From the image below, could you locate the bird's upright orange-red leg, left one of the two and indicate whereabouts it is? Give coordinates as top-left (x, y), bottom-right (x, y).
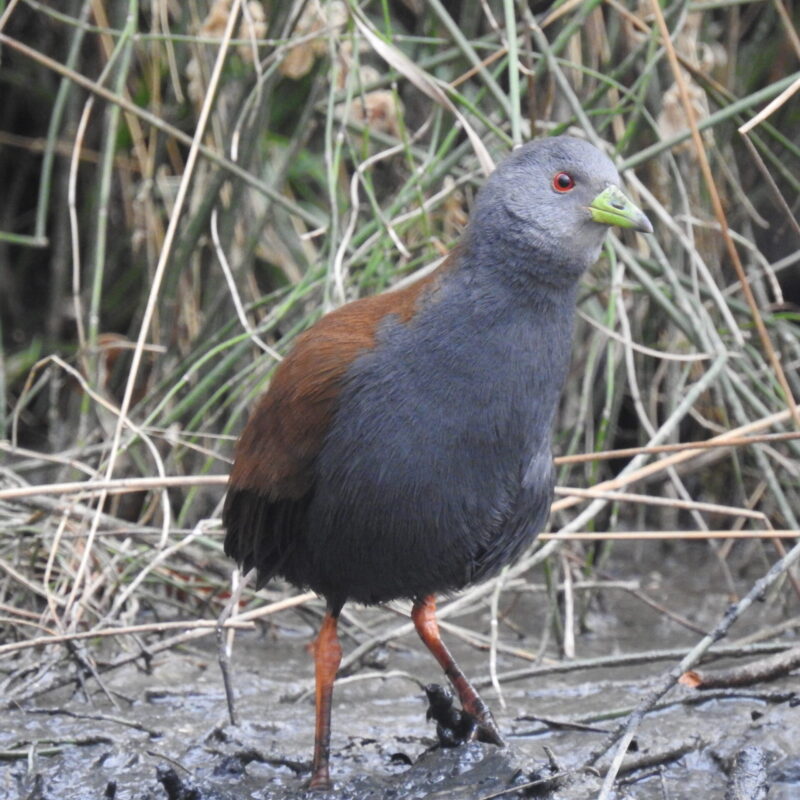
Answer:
top-left (309, 611), bottom-right (342, 789)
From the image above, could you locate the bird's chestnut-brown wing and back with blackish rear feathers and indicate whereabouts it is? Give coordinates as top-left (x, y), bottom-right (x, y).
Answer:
top-left (223, 255), bottom-right (453, 585)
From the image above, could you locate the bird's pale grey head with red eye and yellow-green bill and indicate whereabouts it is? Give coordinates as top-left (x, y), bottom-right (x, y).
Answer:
top-left (471, 136), bottom-right (653, 283)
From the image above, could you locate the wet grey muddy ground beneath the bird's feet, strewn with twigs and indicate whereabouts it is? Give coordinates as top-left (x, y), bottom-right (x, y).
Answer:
top-left (0, 543), bottom-right (800, 800)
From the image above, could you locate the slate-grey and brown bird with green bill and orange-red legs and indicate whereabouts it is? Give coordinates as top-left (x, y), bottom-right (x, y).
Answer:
top-left (223, 136), bottom-right (653, 789)
